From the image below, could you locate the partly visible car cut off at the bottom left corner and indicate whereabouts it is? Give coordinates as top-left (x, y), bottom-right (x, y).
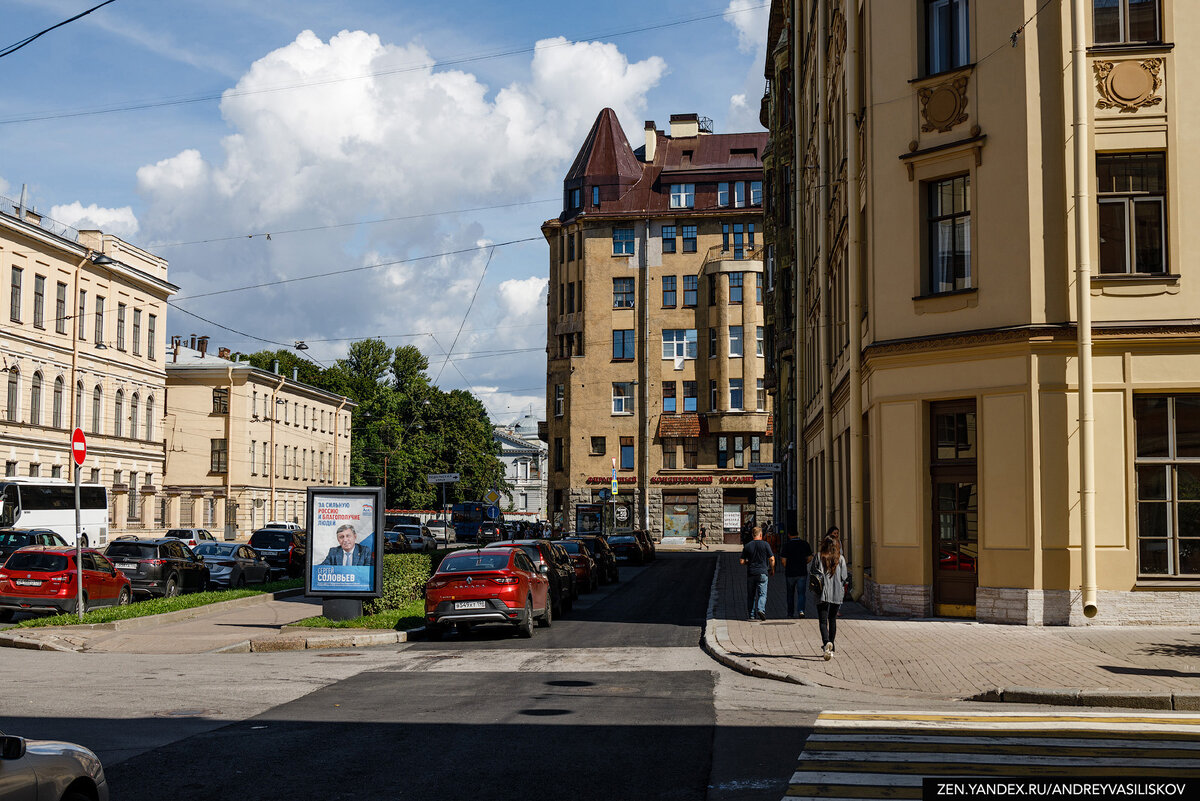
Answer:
top-left (0, 733), bottom-right (108, 801)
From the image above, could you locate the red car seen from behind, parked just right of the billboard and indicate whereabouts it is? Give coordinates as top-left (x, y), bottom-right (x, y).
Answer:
top-left (425, 548), bottom-right (552, 637)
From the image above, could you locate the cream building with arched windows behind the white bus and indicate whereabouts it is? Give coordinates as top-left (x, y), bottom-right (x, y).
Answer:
top-left (0, 198), bottom-right (179, 544)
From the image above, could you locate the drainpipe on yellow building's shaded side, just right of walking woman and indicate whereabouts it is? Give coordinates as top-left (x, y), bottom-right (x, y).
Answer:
top-left (842, 0), bottom-right (864, 601)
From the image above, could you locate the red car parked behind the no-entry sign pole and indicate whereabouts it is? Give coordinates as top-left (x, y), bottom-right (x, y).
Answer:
top-left (0, 546), bottom-right (133, 621)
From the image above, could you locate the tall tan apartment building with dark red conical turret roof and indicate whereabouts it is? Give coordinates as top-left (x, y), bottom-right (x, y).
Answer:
top-left (542, 109), bottom-right (774, 542)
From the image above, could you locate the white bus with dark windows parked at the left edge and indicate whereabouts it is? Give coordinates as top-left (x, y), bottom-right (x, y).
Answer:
top-left (0, 478), bottom-right (108, 546)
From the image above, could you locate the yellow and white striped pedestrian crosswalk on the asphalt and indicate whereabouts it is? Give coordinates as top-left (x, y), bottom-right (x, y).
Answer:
top-left (786, 711), bottom-right (1200, 799)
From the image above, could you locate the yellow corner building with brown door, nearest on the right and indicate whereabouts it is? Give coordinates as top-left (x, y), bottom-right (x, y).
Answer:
top-left (763, 0), bottom-right (1200, 625)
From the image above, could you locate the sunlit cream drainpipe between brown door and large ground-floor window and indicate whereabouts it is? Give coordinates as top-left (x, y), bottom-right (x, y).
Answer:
top-left (1070, 0), bottom-right (1099, 618)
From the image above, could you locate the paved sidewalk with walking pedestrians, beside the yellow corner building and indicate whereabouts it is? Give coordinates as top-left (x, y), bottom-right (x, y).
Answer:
top-left (702, 546), bottom-right (1200, 710)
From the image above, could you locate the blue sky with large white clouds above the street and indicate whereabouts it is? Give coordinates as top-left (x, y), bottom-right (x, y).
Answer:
top-left (0, 0), bottom-right (770, 423)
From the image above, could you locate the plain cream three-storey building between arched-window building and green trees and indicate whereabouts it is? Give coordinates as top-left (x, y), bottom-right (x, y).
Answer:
top-left (160, 335), bottom-right (356, 540)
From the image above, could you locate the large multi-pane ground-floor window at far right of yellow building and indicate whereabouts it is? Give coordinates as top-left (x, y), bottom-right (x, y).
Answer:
top-left (1133, 395), bottom-right (1200, 576)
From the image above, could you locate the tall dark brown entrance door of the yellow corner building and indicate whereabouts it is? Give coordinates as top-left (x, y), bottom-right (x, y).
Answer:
top-left (930, 401), bottom-right (979, 618)
